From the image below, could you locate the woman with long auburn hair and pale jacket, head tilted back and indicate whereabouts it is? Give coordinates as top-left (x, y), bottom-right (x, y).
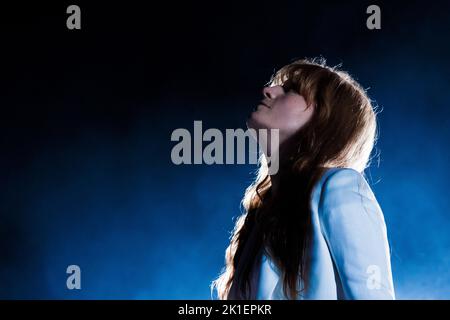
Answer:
top-left (211, 60), bottom-right (395, 299)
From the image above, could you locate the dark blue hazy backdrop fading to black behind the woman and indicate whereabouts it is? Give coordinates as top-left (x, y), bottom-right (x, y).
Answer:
top-left (0, 1), bottom-right (450, 299)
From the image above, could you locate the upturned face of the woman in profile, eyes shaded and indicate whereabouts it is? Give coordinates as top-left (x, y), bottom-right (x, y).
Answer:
top-left (247, 85), bottom-right (314, 139)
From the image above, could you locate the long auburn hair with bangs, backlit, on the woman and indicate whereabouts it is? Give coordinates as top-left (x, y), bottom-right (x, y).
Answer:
top-left (211, 58), bottom-right (377, 299)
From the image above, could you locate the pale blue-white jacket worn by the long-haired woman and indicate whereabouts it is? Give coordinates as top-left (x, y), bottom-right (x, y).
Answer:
top-left (230, 168), bottom-right (395, 300)
